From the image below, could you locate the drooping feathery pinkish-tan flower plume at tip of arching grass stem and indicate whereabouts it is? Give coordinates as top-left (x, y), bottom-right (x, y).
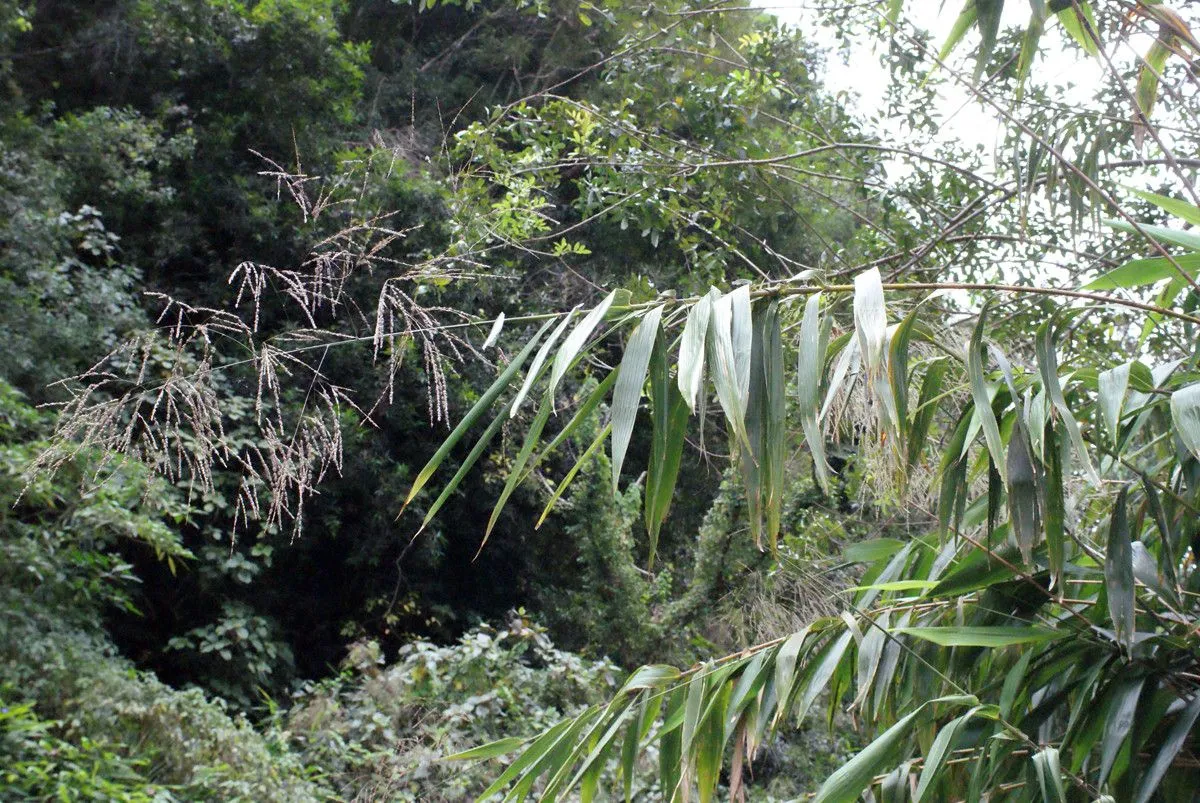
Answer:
top-left (29, 150), bottom-right (474, 535)
